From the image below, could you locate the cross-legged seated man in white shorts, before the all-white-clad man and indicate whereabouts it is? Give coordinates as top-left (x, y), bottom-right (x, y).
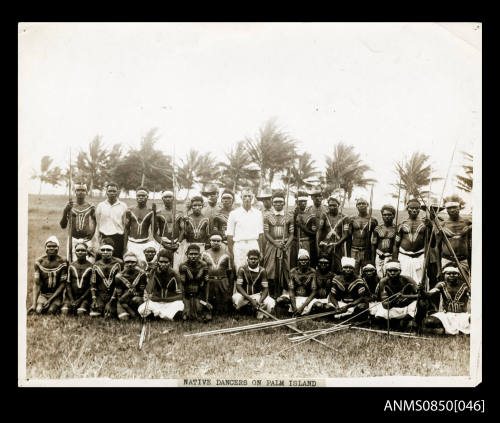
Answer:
top-left (233, 250), bottom-right (275, 319)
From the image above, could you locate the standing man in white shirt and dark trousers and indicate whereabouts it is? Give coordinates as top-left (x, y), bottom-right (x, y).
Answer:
top-left (95, 182), bottom-right (127, 259)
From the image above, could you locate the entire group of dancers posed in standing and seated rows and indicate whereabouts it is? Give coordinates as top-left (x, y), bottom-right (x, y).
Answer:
top-left (30, 182), bottom-right (472, 334)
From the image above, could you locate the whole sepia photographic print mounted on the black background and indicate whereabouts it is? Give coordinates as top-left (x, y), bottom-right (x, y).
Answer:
top-left (17, 22), bottom-right (483, 388)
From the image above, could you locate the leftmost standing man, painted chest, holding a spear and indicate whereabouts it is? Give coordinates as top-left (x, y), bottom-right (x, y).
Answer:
top-left (59, 183), bottom-right (96, 263)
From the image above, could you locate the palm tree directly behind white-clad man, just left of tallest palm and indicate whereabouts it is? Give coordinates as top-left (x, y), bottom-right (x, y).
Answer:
top-left (219, 141), bottom-right (259, 192)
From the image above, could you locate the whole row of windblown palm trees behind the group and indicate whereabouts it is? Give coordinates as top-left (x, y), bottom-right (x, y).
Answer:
top-left (32, 120), bottom-right (472, 204)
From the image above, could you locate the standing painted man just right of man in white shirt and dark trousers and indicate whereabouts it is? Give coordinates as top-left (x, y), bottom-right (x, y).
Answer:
top-left (124, 187), bottom-right (156, 260)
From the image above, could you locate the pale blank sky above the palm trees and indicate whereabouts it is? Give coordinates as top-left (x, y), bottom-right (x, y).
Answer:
top-left (18, 23), bottom-right (482, 207)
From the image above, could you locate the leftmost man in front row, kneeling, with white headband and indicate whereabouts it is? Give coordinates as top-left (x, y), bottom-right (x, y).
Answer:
top-left (28, 236), bottom-right (68, 314)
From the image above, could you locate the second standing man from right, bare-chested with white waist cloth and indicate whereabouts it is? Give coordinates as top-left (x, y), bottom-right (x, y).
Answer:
top-left (392, 199), bottom-right (432, 284)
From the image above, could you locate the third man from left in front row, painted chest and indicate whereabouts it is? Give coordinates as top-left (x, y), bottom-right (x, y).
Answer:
top-left (90, 242), bottom-right (123, 317)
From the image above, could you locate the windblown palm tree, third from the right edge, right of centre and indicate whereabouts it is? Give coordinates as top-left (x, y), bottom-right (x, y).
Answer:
top-left (324, 142), bottom-right (376, 207)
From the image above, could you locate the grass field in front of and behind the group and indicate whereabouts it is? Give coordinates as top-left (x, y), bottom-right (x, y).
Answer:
top-left (22, 196), bottom-right (470, 379)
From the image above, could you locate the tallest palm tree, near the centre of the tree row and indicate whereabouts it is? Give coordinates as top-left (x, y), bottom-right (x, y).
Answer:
top-left (244, 119), bottom-right (296, 187)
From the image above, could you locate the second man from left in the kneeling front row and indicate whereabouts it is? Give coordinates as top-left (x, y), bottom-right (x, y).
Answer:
top-left (61, 242), bottom-right (92, 316)
